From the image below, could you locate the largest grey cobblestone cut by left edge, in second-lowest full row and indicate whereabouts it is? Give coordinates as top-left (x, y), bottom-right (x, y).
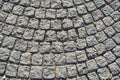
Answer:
top-left (0, 48), bottom-right (10, 61)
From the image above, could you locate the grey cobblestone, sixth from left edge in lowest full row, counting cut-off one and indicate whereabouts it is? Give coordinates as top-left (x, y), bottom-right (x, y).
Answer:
top-left (56, 66), bottom-right (67, 79)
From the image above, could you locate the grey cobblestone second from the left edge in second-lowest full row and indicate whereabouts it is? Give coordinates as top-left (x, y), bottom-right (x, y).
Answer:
top-left (9, 50), bottom-right (21, 64)
